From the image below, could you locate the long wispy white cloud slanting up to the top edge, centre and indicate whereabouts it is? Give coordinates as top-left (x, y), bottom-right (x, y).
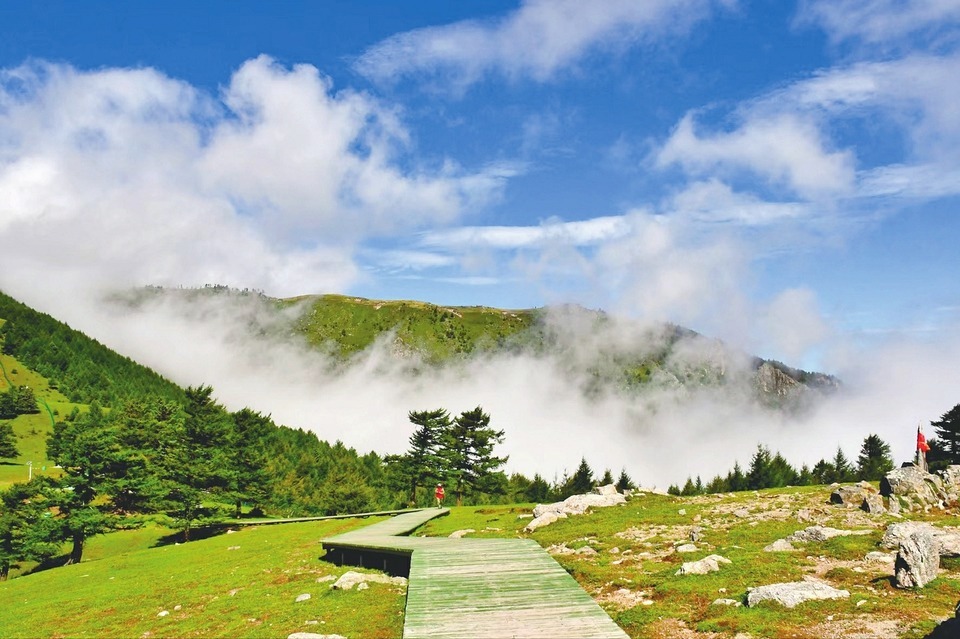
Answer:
top-left (356, 0), bottom-right (731, 86)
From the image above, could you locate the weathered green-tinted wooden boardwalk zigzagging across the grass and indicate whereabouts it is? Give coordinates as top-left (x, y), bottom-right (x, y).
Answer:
top-left (323, 509), bottom-right (627, 639)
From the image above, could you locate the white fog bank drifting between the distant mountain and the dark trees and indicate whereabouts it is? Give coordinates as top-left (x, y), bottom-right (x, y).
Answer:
top-left (3, 282), bottom-right (960, 488)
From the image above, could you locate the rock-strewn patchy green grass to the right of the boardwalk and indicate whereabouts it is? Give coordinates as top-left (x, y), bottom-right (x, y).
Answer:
top-left (417, 486), bottom-right (960, 639)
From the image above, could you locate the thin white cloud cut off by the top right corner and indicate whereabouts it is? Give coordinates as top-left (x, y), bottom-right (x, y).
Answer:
top-left (798, 0), bottom-right (960, 46)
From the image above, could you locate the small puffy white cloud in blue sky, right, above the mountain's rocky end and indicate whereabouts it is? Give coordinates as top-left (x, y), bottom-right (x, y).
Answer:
top-left (656, 113), bottom-right (854, 198)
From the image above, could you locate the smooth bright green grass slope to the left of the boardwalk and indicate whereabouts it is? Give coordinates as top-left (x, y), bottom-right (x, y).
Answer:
top-left (0, 519), bottom-right (404, 639)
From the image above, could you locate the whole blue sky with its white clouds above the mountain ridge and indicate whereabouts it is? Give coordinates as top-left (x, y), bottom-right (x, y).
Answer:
top-left (0, 0), bottom-right (960, 370)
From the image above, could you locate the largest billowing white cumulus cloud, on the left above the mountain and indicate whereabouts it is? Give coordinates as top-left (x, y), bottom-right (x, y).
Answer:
top-left (0, 56), bottom-right (516, 308)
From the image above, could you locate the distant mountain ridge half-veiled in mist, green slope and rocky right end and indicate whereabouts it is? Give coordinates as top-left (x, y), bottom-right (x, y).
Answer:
top-left (107, 285), bottom-right (840, 406)
